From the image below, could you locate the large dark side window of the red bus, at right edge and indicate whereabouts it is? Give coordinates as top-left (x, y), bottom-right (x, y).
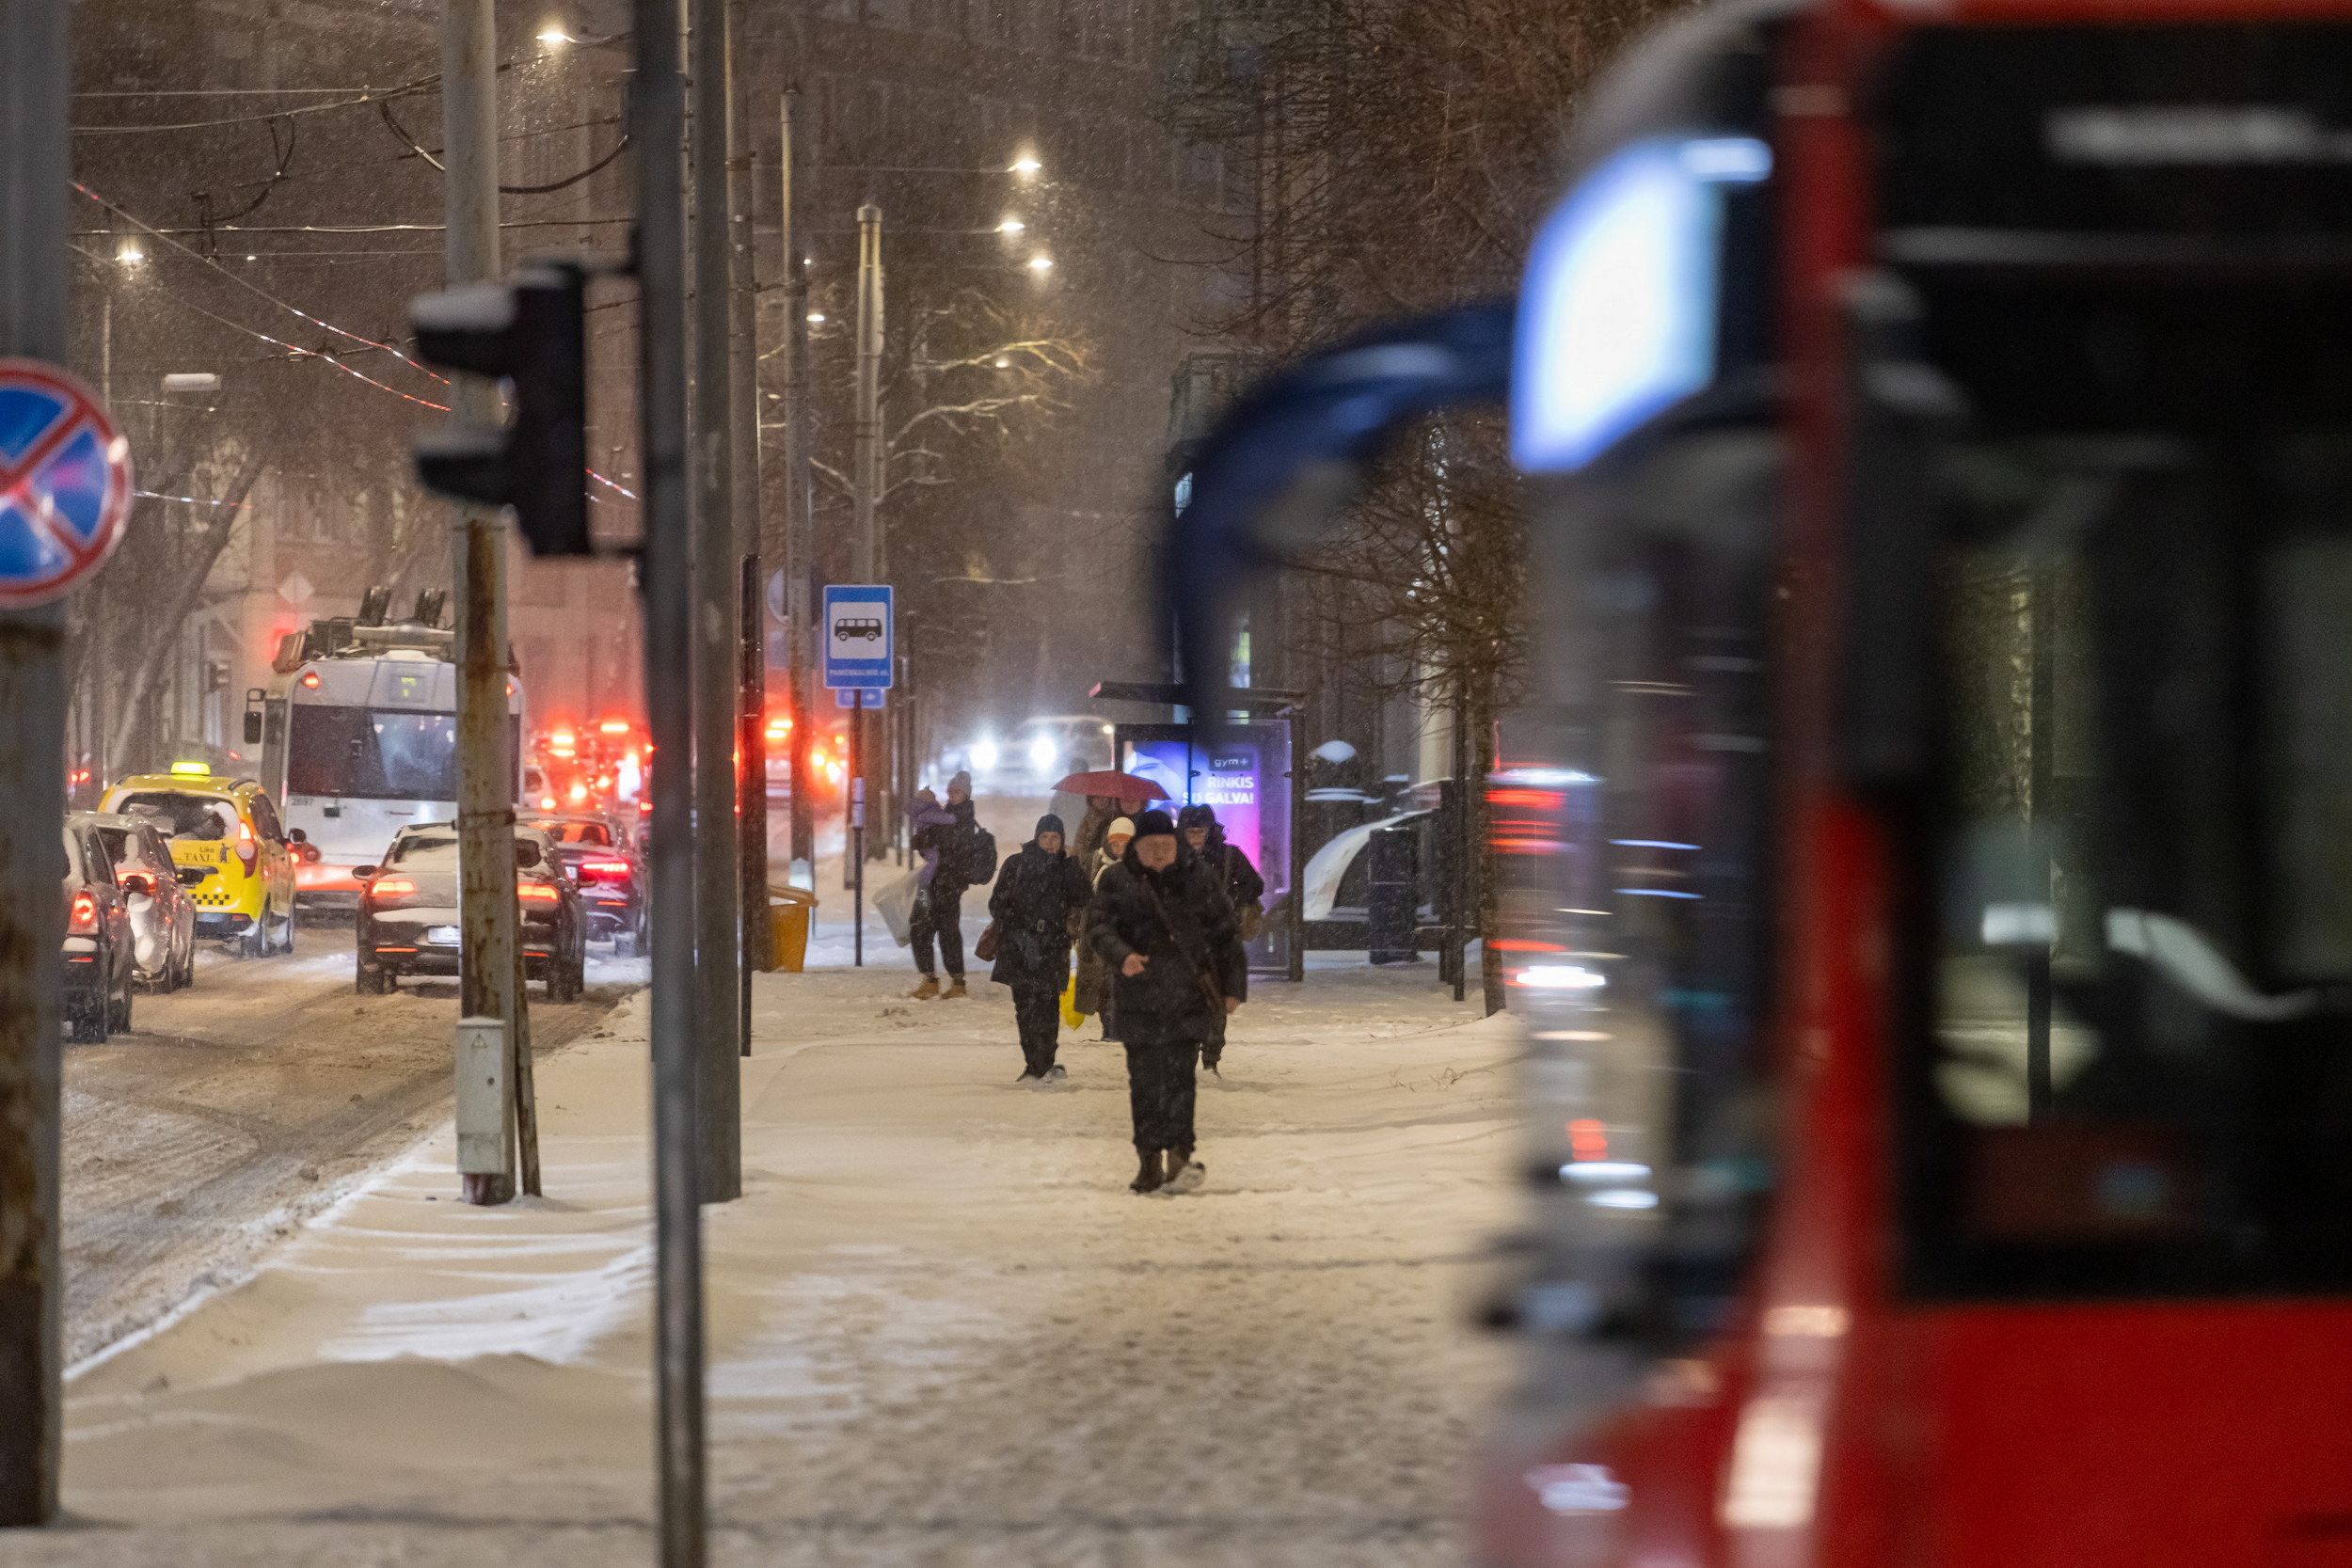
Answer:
top-left (1910, 428), bottom-right (2352, 1295)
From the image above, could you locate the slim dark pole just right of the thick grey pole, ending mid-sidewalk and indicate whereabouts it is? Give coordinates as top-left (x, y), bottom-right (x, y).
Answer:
top-left (727, 0), bottom-right (776, 1029)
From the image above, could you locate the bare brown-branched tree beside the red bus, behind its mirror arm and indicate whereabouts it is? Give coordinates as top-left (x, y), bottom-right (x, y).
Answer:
top-left (1174, 0), bottom-right (1673, 1011)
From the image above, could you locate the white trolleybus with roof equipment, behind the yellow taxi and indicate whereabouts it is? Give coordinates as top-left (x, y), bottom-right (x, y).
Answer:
top-left (245, 588), bottom-right (522, 910)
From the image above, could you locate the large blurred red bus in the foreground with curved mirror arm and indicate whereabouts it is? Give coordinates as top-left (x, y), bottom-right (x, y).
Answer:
top-left (1174, 0), bottom-right (2352, 1568)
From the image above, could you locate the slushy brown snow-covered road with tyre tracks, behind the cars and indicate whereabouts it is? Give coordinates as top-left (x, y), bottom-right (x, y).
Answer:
top-left (64, 924), bottom-right (643, 1364)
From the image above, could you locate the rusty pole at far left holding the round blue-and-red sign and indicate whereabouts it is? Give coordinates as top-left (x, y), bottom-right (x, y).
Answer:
top-left (0, 0), bottom-right (73, 1526)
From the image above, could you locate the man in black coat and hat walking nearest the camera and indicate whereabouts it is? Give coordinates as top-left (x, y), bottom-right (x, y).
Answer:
top-left (1087, 811), bottom-right (1249, 1192)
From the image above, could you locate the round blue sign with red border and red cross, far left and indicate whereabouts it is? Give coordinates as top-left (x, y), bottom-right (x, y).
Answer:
top-left (0, 359), bottom-right (132, 609)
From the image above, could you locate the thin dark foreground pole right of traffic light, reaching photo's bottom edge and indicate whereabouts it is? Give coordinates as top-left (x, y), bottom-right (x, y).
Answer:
top-left (633, 0), bottom-right (708, 1542)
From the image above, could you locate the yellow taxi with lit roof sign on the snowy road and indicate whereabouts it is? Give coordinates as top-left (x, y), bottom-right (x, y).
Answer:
top-left (99, 762), bottom-right (301, 959)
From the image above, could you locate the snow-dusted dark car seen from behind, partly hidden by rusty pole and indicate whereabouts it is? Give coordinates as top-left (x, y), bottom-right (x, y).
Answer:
top-left (351, 823), bottom-right (588, 1002)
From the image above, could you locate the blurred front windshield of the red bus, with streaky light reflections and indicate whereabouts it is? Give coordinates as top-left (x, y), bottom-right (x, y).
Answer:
top-left (1489, 430), bottom-right (1778, 1350)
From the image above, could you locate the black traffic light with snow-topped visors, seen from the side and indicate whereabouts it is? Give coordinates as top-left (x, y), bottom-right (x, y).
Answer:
top-left (409, 261), bottom-right (596, 555)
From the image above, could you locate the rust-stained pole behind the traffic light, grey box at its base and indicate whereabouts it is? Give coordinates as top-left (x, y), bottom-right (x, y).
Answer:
top-left (442, 0), bottom-right (539, 1204)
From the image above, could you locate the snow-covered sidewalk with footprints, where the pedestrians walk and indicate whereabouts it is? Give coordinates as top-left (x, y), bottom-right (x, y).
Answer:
top-left (13, 949), bottom-right (1515, 1568)
